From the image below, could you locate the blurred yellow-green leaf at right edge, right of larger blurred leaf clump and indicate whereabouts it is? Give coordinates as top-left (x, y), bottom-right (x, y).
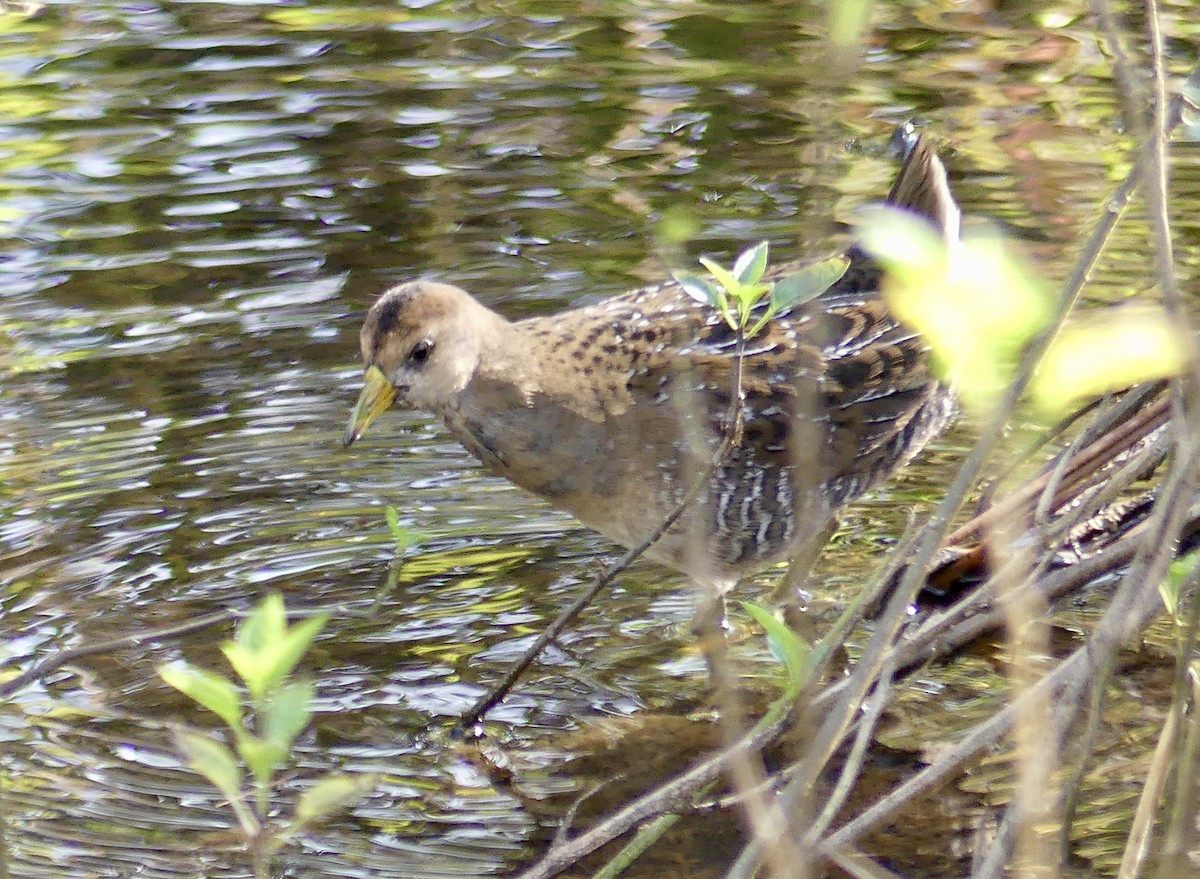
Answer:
top-left (1030, 309), bottom-right (1189, 418)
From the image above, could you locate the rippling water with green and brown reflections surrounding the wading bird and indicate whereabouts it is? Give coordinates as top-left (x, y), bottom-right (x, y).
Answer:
top-left (0, 0), bottom-right (1200, 877)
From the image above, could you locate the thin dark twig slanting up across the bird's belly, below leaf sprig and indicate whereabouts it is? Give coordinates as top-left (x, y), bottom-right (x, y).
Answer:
top-left (458, 338), bottom-right (745, 730)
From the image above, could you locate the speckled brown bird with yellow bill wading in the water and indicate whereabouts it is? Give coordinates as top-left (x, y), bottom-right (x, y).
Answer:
top-left (346, 130), bottom-right (959, 587)
